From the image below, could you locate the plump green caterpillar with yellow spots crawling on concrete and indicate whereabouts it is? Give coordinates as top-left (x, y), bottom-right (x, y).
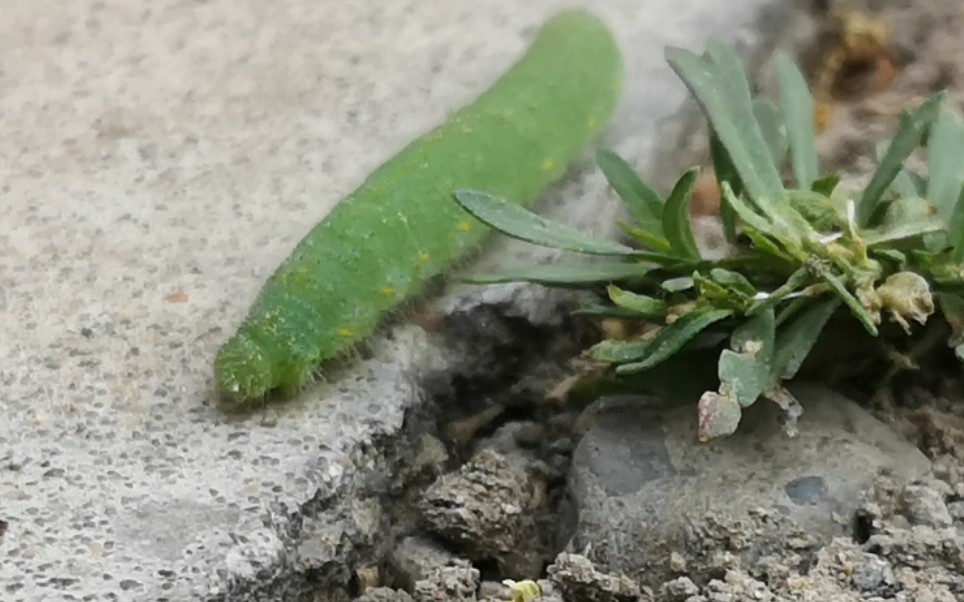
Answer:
top-left (214, 11), bottom-right (622, 405)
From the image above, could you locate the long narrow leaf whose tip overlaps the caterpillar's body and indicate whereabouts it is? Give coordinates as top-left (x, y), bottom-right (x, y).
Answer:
top-left (455, 190), bottom-right (652, 258)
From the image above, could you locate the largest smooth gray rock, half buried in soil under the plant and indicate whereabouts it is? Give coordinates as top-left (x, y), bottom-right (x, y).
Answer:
top-left (567, 386), bottom-right (929, 585)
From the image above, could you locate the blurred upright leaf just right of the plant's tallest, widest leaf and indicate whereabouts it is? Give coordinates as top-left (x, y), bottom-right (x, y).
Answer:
top-left (774, 53), bottom-right (816, 194)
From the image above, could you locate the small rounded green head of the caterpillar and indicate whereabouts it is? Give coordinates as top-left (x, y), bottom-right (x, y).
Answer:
top-left (214, 333), bottom-right (274, 406)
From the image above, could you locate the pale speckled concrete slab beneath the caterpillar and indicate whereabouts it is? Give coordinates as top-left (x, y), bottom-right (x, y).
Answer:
top-left (0, 0), bottom-right (792, 602)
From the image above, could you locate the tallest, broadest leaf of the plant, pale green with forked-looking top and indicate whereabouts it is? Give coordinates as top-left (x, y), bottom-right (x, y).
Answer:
top-left (665, 42), bottom-right (783, 203)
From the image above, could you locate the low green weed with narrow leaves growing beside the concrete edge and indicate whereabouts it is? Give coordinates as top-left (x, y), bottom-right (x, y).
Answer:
top-left (455, 42), bottom-right (964, 441)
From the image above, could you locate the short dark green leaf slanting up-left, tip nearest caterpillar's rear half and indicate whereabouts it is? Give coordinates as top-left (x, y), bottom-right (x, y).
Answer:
top-left (596, 149), bottom-right (670, 251)
